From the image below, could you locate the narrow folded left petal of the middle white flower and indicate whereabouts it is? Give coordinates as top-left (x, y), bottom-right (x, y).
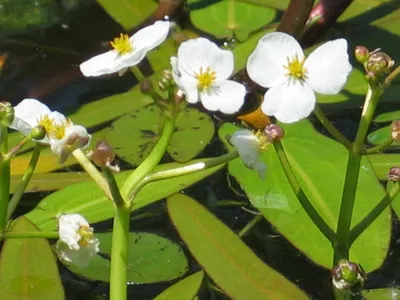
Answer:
top-left (170, 57), bottom-right (199, 103)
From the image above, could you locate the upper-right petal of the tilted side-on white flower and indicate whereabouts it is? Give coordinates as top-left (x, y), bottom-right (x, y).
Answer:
top-left (129, 21), bottom-right (171, 51)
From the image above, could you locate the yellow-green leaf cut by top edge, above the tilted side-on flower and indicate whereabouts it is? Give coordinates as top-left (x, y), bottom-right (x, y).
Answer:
top-left (97, 0), bottom-right (158, 30)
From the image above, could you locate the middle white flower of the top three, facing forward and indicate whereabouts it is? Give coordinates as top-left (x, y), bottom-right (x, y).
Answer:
top-left (171, 38), bottom-right (246, 114)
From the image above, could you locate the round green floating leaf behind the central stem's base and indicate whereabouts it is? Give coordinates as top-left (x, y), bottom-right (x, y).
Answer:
top-left (66, 232), bottom-right (188, 284)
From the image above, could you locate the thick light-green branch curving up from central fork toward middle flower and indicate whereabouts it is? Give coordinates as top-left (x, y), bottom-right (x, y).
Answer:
top-left (121, 114), bottom-right (175, 199)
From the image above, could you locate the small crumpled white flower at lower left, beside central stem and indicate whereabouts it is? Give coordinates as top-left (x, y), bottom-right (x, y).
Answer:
top-left (57, 214), bottom-right (100, 267)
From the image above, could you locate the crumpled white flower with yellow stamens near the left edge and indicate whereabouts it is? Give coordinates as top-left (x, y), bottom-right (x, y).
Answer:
top-left (10, 99), bottom-right (91, 162)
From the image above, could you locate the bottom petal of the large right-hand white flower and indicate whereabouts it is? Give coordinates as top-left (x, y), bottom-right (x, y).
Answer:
top-left (261, 81), bottom-right (315, 123)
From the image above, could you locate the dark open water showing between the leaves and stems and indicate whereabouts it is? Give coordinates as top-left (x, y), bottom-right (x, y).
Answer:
top-left (0, 4), bottom-right (400, 300)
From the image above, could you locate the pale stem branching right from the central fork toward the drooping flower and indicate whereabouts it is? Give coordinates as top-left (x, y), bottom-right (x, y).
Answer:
top-left (131, 150), bottom-right (239, 197)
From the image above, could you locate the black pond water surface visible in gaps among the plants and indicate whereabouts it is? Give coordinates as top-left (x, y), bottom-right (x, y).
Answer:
top-left (0, 1), bottom-right (400, 300)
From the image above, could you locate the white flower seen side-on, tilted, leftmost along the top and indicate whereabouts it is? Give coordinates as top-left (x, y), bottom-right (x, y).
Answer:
top-left (80, 21), bottom-right (170, 77)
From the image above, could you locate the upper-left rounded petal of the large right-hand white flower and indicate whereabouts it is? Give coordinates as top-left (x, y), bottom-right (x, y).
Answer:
top-left (247, 32), bottom-right (304, 88)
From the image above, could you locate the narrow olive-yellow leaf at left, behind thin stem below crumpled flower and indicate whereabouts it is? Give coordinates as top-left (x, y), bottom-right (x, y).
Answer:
top-left (11, 172), bottom-right (90, 193)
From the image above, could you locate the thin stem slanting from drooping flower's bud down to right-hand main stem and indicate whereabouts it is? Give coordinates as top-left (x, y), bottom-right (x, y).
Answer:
top-left (274, 141), bottom-right (336, 243)
